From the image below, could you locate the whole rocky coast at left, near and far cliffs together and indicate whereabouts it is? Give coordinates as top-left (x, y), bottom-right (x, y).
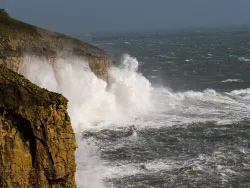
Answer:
top-left (0, 9), bottom-right (112, 188)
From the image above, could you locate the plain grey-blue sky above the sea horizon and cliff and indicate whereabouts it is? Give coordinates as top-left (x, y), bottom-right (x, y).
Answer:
top-left (0, 0), bottom-right (250, 33)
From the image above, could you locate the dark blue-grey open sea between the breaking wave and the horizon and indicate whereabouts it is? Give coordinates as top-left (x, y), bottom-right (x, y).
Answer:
top-left (92, 27), bottom-right (250, 90)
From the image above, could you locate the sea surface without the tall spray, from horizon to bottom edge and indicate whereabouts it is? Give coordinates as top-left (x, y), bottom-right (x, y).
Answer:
top-left (76, 27), bottom-right (250, 188)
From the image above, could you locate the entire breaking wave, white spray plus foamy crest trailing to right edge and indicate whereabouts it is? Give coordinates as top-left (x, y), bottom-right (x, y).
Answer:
top-left (18, 55), bottom-right (250, 188)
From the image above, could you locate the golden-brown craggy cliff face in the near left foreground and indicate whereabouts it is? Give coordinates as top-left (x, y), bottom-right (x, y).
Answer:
top-left (0, 65), bottom-right (76, 188)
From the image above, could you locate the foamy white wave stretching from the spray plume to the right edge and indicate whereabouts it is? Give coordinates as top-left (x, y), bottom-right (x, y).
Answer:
top-left (146, 88), bottom-right (250, 126)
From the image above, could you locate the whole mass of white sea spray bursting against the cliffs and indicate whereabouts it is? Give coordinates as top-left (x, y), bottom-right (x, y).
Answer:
top-left (18, 55), bottom-right (153, 188)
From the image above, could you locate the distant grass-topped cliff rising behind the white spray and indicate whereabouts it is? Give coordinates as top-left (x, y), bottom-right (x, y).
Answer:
top-left (0, 9), bottom-right (112, 80)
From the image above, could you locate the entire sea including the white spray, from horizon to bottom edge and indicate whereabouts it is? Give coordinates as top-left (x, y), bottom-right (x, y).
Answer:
top-left (19, 27), bottom-right (250, 188)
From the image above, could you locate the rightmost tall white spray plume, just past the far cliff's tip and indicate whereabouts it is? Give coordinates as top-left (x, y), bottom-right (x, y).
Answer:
top-left (108, 55), bottom-right (153, 120)
